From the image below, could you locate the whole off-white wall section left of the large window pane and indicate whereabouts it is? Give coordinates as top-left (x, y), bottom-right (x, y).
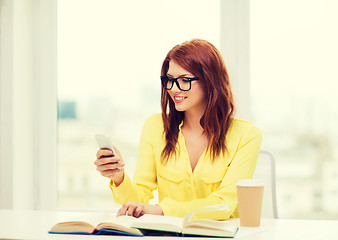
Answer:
top-left (0, 0), bottom-right (56, 209)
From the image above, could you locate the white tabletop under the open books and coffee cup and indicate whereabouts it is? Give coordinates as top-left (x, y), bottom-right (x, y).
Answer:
top-left (0, 210), bottom-right (338, 240)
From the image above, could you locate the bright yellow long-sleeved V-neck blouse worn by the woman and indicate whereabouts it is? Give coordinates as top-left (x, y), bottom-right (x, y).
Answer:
top-left (110, 114), bottom-right (262, 219)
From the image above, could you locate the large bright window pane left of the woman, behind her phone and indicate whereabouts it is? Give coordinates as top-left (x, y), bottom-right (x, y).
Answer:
top-left (58, 0), bottom-right (220, 208)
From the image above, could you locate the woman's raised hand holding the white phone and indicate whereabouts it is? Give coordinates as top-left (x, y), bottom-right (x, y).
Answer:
top-left (94, 147), bottom-right (124, 186)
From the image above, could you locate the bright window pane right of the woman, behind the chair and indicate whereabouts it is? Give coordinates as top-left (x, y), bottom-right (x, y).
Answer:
top-left (251, 0), bottom-right (338, 219)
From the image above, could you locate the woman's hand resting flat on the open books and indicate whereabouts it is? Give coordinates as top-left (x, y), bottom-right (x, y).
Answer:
top-left (117, 201), bottom-right (163, 218)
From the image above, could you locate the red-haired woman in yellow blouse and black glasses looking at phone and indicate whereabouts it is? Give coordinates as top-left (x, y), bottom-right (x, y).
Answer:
top-left (95, 39), bottom-right (261, 219)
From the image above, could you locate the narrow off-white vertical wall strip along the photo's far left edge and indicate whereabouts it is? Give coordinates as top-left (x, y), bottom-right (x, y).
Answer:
top-left (0, 1), bottom-right (13, 208)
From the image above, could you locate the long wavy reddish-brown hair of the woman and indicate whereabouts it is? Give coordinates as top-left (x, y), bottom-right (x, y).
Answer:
top-left (161, 39), bottom-right (235, 164)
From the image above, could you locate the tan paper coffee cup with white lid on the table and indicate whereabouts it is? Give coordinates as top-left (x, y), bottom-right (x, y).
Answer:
top-left (237, 179), bottom-right (264, 227)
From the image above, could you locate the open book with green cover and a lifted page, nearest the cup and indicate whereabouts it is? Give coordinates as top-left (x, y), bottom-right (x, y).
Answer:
top-left (132, 204), bottom-right (239, 237)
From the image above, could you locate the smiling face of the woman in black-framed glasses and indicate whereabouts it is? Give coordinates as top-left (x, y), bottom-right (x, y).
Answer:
top-left (167, 61), bottom-right (207, 114)
